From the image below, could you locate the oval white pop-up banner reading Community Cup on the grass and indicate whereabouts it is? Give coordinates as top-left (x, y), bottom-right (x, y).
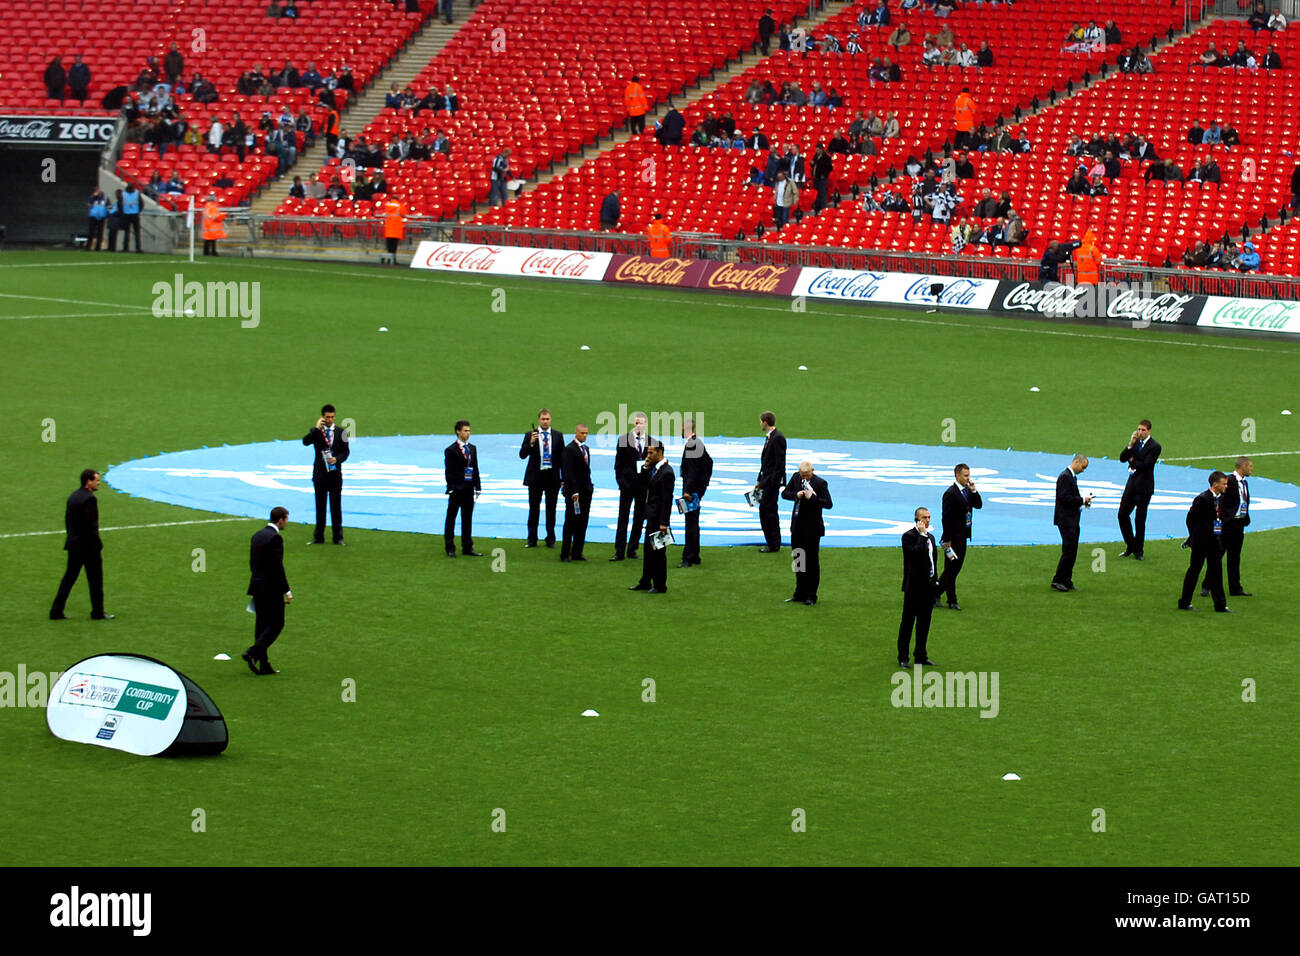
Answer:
top-left (46, 654), bottom-right (229, 757)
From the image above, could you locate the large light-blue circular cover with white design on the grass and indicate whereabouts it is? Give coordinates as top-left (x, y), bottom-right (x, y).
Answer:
top-left (105, 434), bottom-right (1300, 548)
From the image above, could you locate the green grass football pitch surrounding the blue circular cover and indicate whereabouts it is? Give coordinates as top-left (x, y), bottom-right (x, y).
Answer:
top-left (0, 252), bottom-right (1300, 866)
